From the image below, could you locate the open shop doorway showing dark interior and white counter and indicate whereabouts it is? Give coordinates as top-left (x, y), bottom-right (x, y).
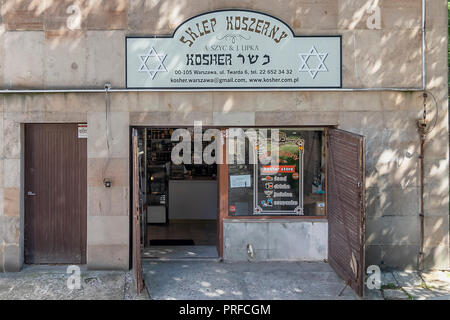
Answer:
top-left (134, 127), bottom-right (219, 259)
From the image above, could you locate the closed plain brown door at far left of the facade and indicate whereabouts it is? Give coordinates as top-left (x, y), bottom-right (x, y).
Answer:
top-left (24, 124), bottom-right (87, 264)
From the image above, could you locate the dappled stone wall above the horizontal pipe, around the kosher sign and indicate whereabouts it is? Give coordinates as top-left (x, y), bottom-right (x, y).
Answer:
top-left (0, 0), bottom-right (428, 88)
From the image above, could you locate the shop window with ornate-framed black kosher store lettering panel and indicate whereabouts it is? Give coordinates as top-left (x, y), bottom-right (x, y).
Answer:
top-left (227, 128), bottom-right (326, 216)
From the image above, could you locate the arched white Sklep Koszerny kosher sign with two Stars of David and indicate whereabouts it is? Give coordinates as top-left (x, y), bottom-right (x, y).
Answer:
top-left (126, 10), bottom-right (342, 90)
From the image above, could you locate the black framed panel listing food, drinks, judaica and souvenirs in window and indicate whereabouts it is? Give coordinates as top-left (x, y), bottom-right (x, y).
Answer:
top-left (254, 130), bottom-right (304, 215)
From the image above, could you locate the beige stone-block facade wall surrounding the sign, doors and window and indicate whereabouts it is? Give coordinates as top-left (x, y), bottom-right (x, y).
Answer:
top-left (0, 0), bottom-right (449, 271)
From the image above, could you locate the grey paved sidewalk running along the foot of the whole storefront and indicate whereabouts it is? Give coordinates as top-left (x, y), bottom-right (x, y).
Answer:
top-left (0, 260), bottom-right (450, 300)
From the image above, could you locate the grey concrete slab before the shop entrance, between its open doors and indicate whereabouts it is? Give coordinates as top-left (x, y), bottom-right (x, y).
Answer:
top-left (143, 260), bottom-right (357, 300)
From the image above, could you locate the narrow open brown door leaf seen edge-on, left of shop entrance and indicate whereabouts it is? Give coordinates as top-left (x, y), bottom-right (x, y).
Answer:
top-left (132, 129), bottom-right (144, 294)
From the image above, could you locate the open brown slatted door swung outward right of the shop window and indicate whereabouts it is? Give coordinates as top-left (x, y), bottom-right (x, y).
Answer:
top-left (327, 129), bottom-right (365, 296)
